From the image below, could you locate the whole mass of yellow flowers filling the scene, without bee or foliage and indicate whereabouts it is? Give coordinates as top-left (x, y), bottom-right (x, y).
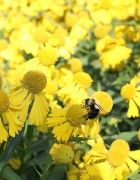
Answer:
top-left (0, 0), bottom-right (140, 180)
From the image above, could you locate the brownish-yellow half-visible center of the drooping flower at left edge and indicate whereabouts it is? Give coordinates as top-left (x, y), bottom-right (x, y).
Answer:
top-left (0, 90), bottom-right (9, 114)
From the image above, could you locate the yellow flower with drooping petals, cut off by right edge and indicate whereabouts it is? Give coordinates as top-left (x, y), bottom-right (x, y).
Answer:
top-left (121, 76), bottom-right (140, 117)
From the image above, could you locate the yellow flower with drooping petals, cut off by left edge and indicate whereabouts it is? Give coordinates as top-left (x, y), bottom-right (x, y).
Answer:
top-left (0, 90), bottom-right (22, 143)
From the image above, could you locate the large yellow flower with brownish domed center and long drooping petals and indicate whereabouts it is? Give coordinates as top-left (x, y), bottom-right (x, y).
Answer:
top-left (11, 61), bottom-right (48, 126)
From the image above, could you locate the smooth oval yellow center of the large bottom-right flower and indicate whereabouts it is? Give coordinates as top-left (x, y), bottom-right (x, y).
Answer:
top-left (107, 139), bottom-right (130, 166)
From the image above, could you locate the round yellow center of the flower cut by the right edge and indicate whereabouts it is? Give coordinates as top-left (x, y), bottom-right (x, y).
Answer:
top-left (121, 84), bottom-right (136, 100)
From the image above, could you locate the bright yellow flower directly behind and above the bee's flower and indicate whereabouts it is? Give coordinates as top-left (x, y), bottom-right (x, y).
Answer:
top-left (57, 68), bottom-right (93, 104)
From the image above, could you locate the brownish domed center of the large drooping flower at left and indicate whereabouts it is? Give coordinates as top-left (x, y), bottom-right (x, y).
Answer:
top-left (22, 71), bottom-right (47, 94)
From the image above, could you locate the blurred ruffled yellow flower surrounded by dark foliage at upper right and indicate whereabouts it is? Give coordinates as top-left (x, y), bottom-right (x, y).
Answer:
top-left (96, 36), bottom-right (132, 70)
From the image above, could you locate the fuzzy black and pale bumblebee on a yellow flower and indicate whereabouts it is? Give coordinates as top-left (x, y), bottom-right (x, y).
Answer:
top-left (83, 98), bottom-right (101, 120)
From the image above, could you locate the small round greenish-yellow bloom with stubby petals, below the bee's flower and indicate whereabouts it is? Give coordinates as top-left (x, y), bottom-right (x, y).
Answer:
top-left (50, 144), bottom-right (74, 164)
